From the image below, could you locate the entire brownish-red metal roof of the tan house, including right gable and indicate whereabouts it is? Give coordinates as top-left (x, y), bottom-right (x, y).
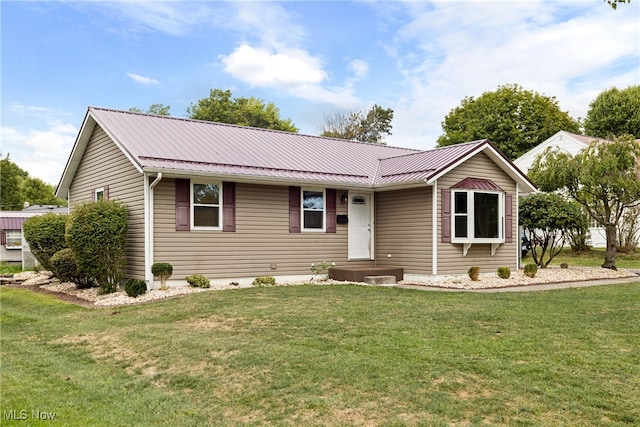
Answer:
top-left (58, 107), bottom-right (534, 197)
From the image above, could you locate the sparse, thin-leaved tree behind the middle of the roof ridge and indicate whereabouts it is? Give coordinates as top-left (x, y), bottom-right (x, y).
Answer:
top-left (320, 105), bottom-right (393, 144)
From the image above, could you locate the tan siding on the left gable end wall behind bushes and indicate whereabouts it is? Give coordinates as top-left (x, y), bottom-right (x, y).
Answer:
top-left (69, 125), bottom-right (144, 279)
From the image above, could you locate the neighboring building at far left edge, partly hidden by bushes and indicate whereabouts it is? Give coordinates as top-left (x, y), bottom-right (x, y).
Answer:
top-left (0, 205), bottom-right (67, 269)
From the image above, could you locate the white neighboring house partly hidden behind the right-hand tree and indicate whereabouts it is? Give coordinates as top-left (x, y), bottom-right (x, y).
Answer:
top-left (513, 130), bottom-right (607, 248)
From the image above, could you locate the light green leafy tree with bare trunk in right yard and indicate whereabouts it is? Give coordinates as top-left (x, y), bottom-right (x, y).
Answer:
top-left (529, 135), bottom-right (640, 270)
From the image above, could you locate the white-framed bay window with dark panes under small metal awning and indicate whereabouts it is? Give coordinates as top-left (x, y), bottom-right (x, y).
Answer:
top-left (453, 190), bottom-right (504, 243)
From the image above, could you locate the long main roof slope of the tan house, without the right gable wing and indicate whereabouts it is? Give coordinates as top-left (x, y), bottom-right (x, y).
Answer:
top-left (89, 107), bottom-right (417, 184)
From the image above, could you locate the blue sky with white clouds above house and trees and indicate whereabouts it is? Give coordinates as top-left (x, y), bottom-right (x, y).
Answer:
top-left (0, 0), bottom-right (640, 184)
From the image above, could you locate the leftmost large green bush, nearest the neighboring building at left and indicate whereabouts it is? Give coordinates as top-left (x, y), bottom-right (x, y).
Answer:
top-left (22, 213), bottom-right (68, 270)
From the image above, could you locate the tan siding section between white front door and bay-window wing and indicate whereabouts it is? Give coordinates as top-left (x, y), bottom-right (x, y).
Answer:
top-left (375, 186), bottom-right (432, 275)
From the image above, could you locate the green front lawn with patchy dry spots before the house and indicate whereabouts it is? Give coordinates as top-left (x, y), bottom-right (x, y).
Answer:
top-left (0, 282), bottom-right (640, 426)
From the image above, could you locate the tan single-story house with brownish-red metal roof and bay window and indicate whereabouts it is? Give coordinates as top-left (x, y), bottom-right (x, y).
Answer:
top-left (57, 107), bottom-right (535, 285)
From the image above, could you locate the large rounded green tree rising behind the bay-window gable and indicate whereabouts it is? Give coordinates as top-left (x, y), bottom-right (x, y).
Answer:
top-left (437, 84), bottom-right (580, 160)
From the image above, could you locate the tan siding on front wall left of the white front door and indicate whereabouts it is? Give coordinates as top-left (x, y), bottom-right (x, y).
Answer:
top-left (153, 179), bottom-right (367, 280)
